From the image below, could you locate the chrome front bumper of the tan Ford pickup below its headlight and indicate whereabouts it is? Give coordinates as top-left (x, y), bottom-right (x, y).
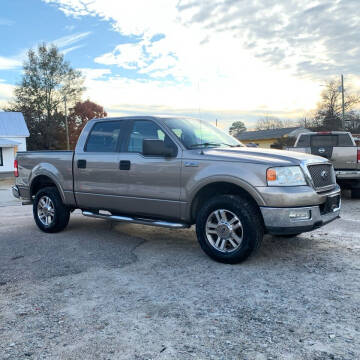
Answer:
top-left (260, 193), bottom-right (341, 235)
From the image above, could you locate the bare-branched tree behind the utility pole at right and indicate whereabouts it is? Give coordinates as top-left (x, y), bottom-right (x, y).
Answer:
top-left (313, 80), bottom-right (360, 130)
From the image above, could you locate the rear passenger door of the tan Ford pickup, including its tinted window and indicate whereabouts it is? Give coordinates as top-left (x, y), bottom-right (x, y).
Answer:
top-left (73, 120), bottom-right (128, 211)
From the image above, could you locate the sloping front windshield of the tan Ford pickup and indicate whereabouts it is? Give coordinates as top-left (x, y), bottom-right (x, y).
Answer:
top-left (165, 118), bottom-right (244, 149)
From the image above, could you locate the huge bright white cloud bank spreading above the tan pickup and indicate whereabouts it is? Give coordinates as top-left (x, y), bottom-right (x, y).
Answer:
top-left (37, 0), bottom-right (360, 126)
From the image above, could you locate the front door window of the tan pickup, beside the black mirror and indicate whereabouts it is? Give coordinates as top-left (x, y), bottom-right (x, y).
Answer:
top-left (127, 120), bottom-right (167, 153)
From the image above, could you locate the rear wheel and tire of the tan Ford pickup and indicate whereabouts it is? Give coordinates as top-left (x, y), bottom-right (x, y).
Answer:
top-left (33, 187), bottom-right (70, 233)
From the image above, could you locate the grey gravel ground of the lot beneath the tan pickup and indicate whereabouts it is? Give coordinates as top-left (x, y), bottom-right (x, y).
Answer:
top-left (0, 195), bottom-right (360, 360)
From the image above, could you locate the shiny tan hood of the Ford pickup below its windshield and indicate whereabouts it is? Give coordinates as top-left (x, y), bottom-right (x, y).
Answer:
top-left (198, 147), bottom-right (327, 166)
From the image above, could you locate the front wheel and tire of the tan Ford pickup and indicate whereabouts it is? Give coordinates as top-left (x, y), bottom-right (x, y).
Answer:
top-left (196, 195), bottom-right (264, 264)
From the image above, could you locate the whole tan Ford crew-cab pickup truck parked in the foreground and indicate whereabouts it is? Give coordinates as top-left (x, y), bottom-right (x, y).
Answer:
top-left (13, 116), bottom-right (341, 263)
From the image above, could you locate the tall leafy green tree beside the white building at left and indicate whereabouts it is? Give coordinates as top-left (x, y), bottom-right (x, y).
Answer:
top-left (5, 43), bottom-right (84, 150)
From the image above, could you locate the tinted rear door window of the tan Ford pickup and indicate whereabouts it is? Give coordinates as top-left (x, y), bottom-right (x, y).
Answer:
top-left (85, 121), bottom-right (122, 152)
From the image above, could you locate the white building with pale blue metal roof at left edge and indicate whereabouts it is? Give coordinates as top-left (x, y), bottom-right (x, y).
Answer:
top-left (0, 112), bottom-right (30, 177)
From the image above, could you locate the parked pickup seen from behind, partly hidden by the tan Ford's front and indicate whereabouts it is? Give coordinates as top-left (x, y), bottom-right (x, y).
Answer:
top-left (288, 131), bottom-right (360, 198)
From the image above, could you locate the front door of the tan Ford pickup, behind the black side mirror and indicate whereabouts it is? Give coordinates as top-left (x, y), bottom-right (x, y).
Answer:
top-left (117, 120), bottom-right (181, 219)
